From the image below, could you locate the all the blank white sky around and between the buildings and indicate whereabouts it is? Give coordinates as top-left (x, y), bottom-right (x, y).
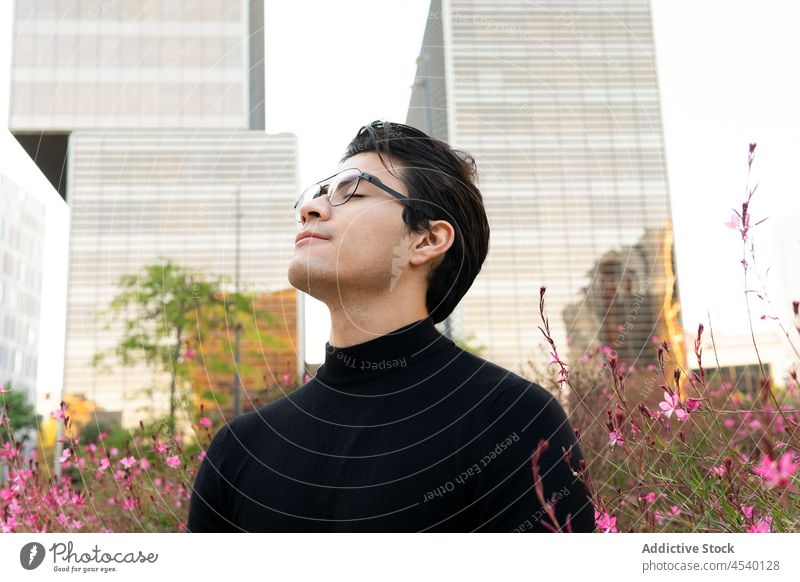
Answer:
top-left (0, 0), bottom-right (800, 374)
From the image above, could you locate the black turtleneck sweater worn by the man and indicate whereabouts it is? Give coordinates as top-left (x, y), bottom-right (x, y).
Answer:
top-left (188, 316), bottom-right (595, 532)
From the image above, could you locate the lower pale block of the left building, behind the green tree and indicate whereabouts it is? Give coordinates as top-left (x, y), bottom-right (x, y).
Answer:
top-left (64, 130), bottom-right (297, 425)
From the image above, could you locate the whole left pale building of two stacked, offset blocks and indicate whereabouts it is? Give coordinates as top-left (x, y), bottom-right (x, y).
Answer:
top-left (10, 0), bottom-right (300, 426)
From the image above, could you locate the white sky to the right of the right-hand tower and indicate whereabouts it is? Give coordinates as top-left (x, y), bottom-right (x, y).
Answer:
top-left (652, 0), bottom-right (800, 368)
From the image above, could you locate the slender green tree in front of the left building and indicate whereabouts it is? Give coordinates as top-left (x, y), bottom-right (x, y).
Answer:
top-left (92, 261), bottom-right (282, 428)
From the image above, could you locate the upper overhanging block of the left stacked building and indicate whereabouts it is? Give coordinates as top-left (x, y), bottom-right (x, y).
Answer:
top-left (10, 0), bottom-right (263, 133)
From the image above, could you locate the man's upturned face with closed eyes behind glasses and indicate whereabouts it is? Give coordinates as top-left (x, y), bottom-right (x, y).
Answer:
top-left (288, 152), bottom-right (412, 306)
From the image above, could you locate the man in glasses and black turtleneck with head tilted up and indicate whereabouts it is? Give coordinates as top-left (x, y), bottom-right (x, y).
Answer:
top-left (188, 121), bottom-right (595, 532)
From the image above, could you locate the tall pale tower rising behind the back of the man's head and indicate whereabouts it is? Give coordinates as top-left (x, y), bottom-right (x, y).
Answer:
top-left (407, 0), bottom-right (678, 371)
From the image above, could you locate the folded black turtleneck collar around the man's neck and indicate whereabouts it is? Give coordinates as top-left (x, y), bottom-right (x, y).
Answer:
top-left (315, 315), bottom-right (454, 385)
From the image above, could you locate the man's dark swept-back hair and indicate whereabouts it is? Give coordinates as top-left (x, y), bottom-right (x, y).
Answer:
top-left (340, 120), bottom-right (489, 323)
